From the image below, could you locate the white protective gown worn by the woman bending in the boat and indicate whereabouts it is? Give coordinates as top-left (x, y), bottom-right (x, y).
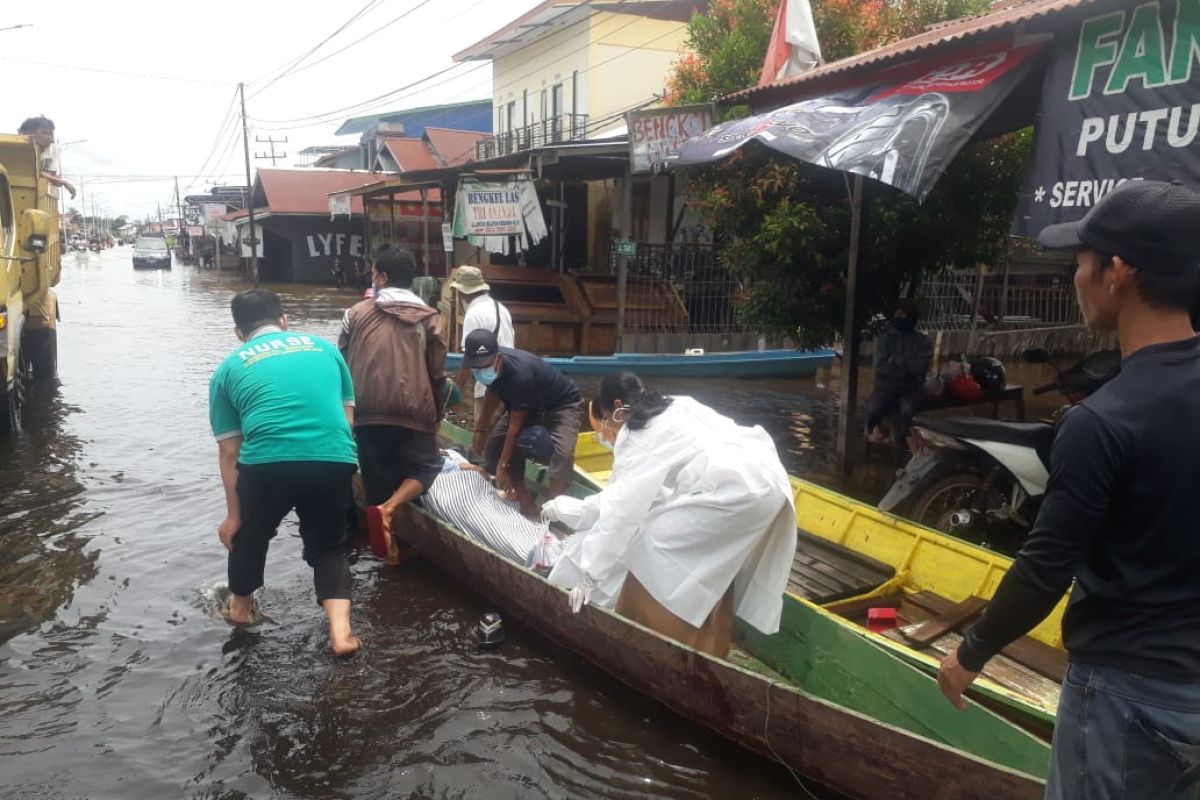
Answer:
top-left (550, 397), bottom-right (796, 633)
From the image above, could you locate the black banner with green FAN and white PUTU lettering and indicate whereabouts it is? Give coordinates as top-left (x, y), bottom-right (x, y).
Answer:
top-left (1013, 0), bottom-right (1200, 236)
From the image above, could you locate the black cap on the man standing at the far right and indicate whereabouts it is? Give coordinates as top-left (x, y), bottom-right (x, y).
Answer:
top-left (1038, 181), bottom-right (1200, 272)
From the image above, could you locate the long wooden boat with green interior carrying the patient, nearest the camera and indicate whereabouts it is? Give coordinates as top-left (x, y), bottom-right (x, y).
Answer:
top-left (388, 425), bottom-right (1049, 800)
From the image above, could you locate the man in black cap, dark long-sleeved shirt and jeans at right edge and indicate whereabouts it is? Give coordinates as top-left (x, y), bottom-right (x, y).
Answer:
top-left (937, 181), bottom-right (1200, 800)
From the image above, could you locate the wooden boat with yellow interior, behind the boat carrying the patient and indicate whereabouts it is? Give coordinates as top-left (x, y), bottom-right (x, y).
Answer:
top-left (576, 433), bottom-right (1067, 741)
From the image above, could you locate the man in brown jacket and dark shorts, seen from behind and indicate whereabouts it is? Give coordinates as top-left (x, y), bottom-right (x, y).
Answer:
top-left (337, 247), bottom-right (446, 564)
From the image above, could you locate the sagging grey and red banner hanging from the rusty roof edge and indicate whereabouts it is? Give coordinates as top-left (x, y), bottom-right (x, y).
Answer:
top-left (673, 44), bottom-right (1042, 200)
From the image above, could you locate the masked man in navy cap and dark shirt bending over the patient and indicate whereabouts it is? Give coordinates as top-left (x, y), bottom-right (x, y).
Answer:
top-left (462, 329), bottom-right (583, 515)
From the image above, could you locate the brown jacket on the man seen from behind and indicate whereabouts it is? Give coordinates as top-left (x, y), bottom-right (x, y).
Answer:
top-left (337, 288), bottom-right (446, 433)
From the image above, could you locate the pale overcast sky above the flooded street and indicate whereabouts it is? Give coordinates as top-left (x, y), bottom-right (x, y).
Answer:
top-left (0, 0), bottom-right (547, 217)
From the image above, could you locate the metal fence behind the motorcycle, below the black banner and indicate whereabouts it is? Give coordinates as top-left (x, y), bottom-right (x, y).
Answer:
top-left (918, 259), bottom-right (1081, 330)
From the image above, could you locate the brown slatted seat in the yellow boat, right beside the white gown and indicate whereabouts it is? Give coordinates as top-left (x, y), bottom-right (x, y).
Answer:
top-left (788, 530), bottom-right (895, 604)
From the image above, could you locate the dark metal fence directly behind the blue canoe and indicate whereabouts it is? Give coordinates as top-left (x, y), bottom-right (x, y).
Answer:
top-left (610, 242), bottom-right (744, 335)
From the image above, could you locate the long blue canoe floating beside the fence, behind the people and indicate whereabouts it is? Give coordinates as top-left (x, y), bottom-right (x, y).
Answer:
top-left (446, 350), bottom-right (834, 378)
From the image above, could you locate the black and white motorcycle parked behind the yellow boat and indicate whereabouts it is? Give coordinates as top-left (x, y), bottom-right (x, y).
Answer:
top-left (878, 349), bottom-right (1121, 553)
